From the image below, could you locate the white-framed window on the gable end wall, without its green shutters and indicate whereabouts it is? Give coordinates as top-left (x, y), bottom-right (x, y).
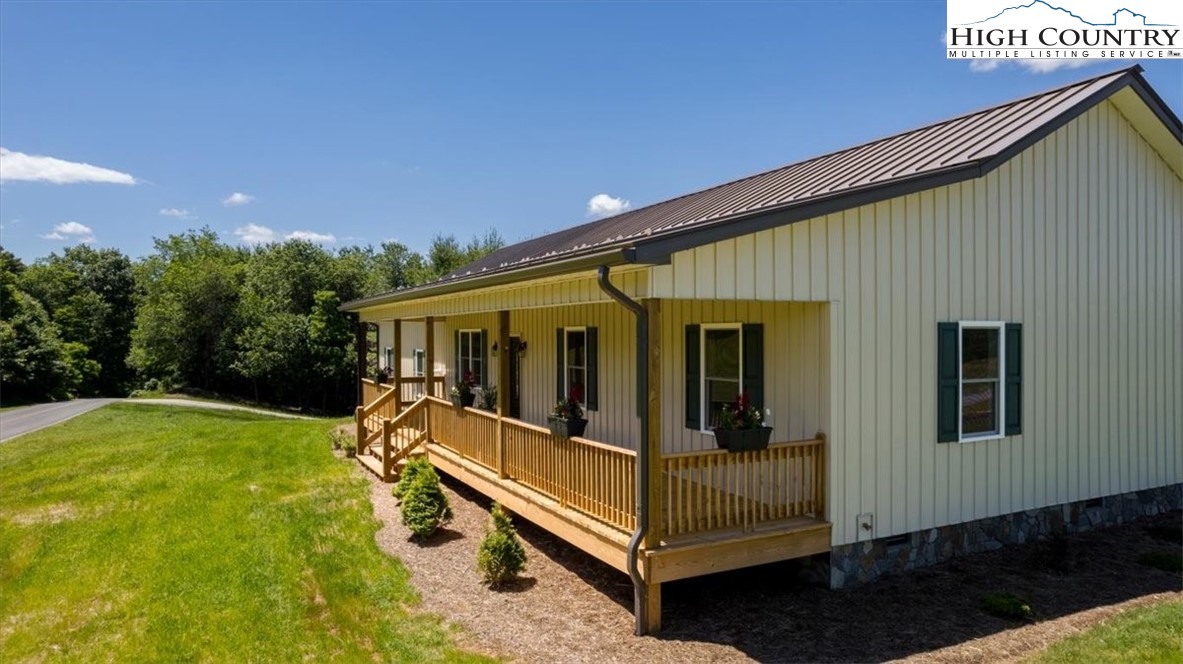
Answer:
top-left (957, 321), bottom-right (1007, 443)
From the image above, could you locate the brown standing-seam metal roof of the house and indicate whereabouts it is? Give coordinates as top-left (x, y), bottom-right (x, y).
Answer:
top-left (344, 66), bottom-right (1179, 309)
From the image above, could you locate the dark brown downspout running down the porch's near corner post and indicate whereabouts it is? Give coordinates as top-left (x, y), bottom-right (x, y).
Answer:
top-left (597, 265), bottom-right (649, 636)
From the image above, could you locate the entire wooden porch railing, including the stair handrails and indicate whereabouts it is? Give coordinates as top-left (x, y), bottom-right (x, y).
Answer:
top-left (357, 389), bottom-right (826, 535)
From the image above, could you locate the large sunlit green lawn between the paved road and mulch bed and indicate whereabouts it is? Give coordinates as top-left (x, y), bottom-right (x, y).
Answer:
top-left (0, 404), bottom-right (487, 662)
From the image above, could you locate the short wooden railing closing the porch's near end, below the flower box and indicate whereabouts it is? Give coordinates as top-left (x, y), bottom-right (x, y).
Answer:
top-left (661, 439), bottom-right (826, 535)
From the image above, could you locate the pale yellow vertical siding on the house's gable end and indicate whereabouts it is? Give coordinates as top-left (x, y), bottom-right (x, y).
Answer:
top-left (651, 97), bottom-right (1183, 543)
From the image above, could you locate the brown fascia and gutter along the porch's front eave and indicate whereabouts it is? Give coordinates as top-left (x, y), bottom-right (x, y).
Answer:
top-left (337, 246), bottom-right (635, 311)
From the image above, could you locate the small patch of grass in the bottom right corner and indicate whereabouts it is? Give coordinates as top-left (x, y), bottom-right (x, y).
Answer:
top-left (1033, 601), bottom-right (1183, 664)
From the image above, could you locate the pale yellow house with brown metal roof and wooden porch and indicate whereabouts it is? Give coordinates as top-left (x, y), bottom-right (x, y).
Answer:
top-left (343, 66), bottom-right (1183, 633)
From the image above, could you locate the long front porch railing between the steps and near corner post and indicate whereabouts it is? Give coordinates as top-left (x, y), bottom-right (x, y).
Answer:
top-left (426, 398), bottom-right (636, 531)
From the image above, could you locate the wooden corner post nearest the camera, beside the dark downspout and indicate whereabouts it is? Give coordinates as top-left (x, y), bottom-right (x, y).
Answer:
top-left (638, 298), bottom-right (662, 634)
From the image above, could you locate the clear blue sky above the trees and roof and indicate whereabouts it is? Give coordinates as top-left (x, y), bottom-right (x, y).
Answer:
top-left (0, 0), bottom-right (1183, 260)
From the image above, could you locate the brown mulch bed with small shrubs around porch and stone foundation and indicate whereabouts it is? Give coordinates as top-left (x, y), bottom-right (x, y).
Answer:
top-left (358, 454), bottom-right (1183, 663)
